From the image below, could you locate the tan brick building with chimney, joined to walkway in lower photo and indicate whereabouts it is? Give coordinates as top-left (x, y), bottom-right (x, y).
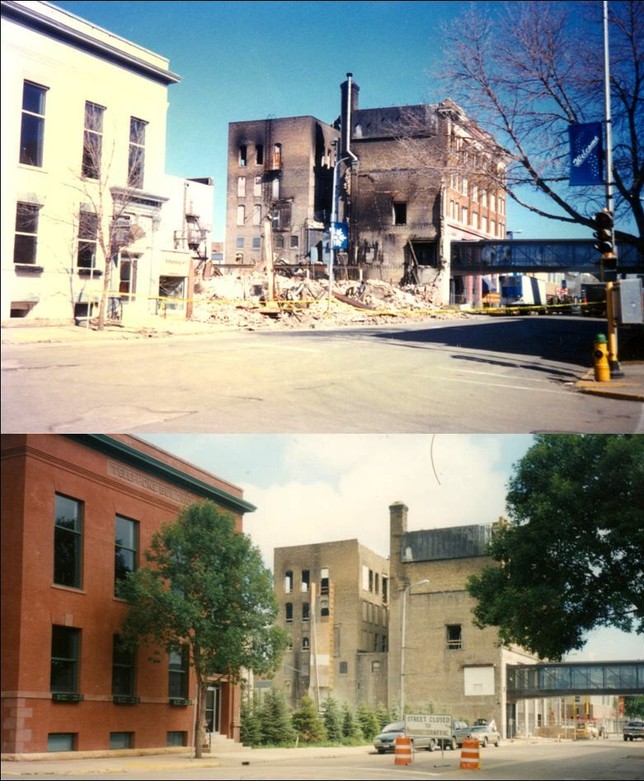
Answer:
top-left (389, 502), bottom-right (548, 737)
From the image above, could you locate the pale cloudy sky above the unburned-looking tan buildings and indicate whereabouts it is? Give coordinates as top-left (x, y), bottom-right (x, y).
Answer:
top-left (142, 434), bottom-right (644, 661)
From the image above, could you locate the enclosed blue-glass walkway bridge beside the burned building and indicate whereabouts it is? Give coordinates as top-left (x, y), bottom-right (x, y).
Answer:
top-left (451, 239), bottom-right (644, 276)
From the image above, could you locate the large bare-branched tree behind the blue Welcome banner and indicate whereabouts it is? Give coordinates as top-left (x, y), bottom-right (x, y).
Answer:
top-left (422, 0), bottom-right (644, 251)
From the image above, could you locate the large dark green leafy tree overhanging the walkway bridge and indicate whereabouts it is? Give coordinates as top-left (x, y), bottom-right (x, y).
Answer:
top-left (467, 434), bottom-right (644, 660)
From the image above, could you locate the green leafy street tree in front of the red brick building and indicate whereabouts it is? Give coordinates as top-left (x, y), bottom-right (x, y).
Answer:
top-left (119, 502), bottom-right (286, 757)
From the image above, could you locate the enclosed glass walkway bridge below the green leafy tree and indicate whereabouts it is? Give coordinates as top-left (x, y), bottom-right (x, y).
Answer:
top-left (506, 661), bottom-right (644, 700)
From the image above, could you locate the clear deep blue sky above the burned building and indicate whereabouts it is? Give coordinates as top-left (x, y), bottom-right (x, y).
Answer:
top-left (54, 0), bottom-right (592, 241)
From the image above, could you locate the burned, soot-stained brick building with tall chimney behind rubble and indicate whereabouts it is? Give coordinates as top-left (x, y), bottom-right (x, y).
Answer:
top-left (226, 73), bottom-right (506, 304)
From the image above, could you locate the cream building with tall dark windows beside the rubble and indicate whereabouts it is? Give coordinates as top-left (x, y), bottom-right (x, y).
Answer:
top-left (1, 2), bottom-right (213, 323)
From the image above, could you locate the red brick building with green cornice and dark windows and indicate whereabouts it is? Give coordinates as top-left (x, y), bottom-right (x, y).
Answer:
top-left (2, 434), bottom-right (255, 756)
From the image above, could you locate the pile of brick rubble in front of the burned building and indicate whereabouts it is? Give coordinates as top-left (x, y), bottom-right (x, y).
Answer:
top-left (191, 273), bottom-right (467, 330)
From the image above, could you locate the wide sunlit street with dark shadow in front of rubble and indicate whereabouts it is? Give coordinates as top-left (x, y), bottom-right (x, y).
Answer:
top-left (2, 317), bottom-right (644, 433)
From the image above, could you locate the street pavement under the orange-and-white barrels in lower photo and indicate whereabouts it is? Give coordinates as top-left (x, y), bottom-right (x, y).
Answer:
top-left (2, 740), bottom-right (644, 781)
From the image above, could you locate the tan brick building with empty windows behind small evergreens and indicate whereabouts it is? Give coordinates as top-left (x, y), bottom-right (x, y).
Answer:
top-left (274, 540), bottom-right (389, 707)
